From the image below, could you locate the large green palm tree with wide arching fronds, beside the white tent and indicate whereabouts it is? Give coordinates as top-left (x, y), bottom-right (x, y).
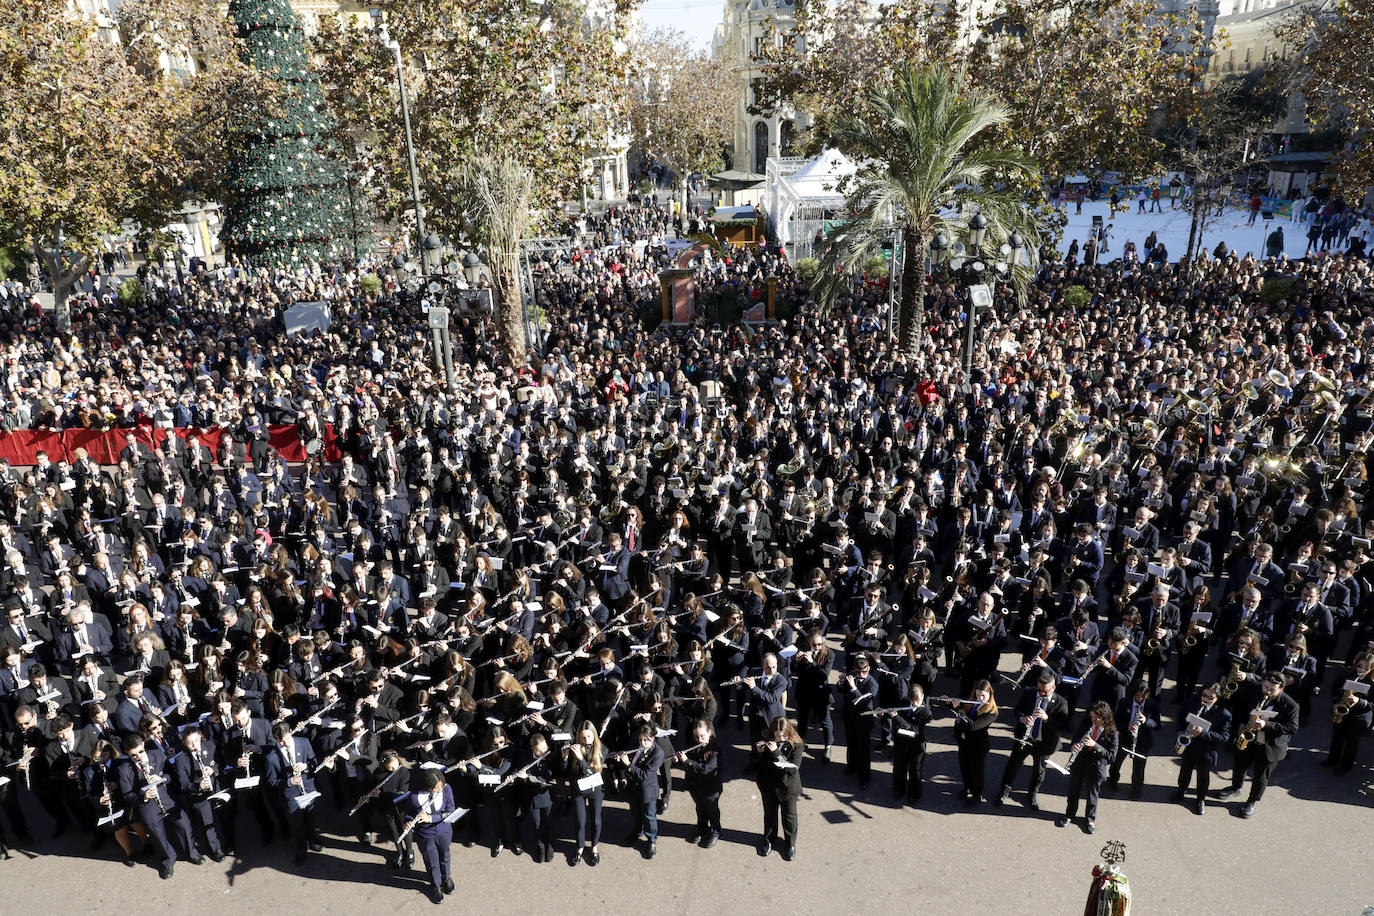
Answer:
top-left (818, 66), bottom-right (1040, 357)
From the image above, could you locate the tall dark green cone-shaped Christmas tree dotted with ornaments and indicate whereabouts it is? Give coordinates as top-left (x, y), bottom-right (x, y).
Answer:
top-left (220, 0), bottom-right (348, 266)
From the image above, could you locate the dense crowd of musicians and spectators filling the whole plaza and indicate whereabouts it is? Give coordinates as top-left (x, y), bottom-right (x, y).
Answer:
top-left (0, 202), bottom-right (1374, 901)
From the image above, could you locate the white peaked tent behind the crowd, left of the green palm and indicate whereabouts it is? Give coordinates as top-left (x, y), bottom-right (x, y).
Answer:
top-left (767, 150), bottom-right (856, 260)
